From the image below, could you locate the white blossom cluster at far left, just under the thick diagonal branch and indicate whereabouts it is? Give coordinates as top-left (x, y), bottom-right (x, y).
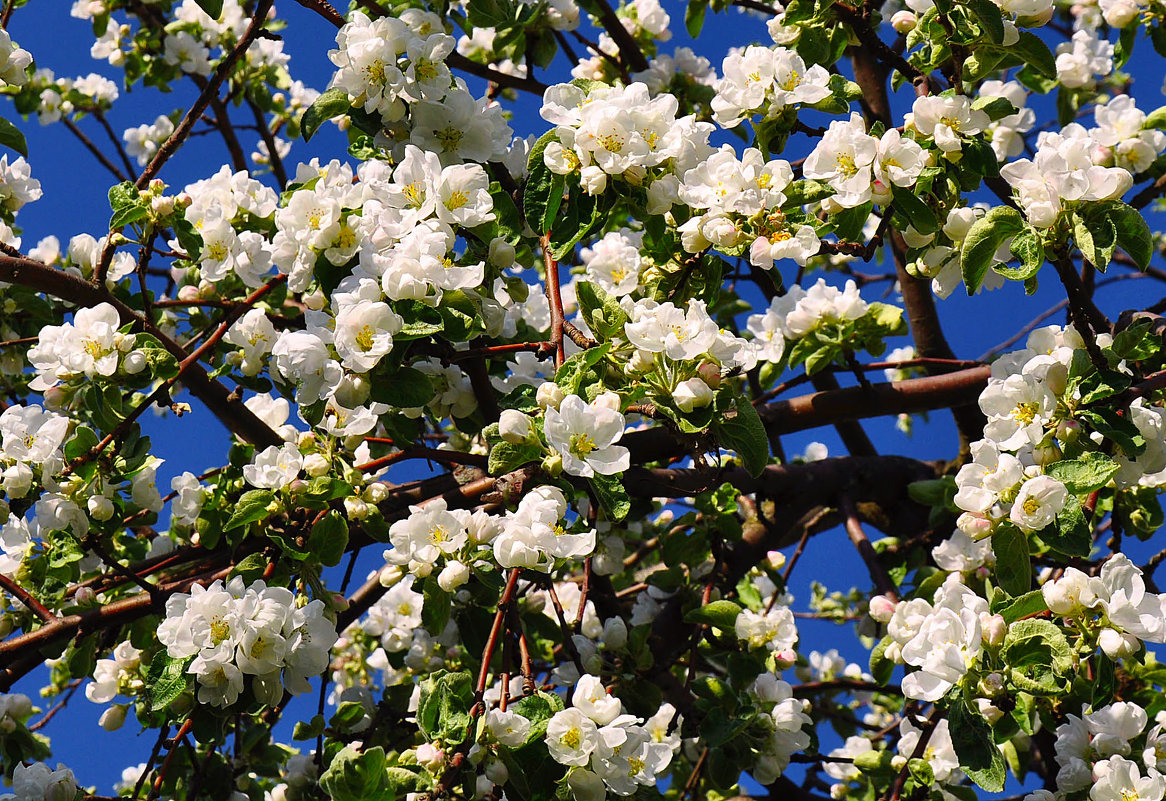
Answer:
top-left (28, 303), bottom-right (147, 392)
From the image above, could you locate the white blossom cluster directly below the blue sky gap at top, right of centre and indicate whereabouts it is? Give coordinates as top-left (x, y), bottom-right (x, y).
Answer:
top-left (712, 45), bottom-right (830, 128)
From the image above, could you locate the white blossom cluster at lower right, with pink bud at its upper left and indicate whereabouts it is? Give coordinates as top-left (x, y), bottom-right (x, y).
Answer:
top-left (885, 574), bottom-right (1003, 702)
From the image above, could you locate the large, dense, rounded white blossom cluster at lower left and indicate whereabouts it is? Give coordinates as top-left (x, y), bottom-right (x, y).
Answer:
top-left (157, 577), bottom-right (336, 707)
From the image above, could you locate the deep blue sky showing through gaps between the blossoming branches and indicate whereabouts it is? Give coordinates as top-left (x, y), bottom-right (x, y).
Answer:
top-left (0, 0), bottom-right (1163, 791)
